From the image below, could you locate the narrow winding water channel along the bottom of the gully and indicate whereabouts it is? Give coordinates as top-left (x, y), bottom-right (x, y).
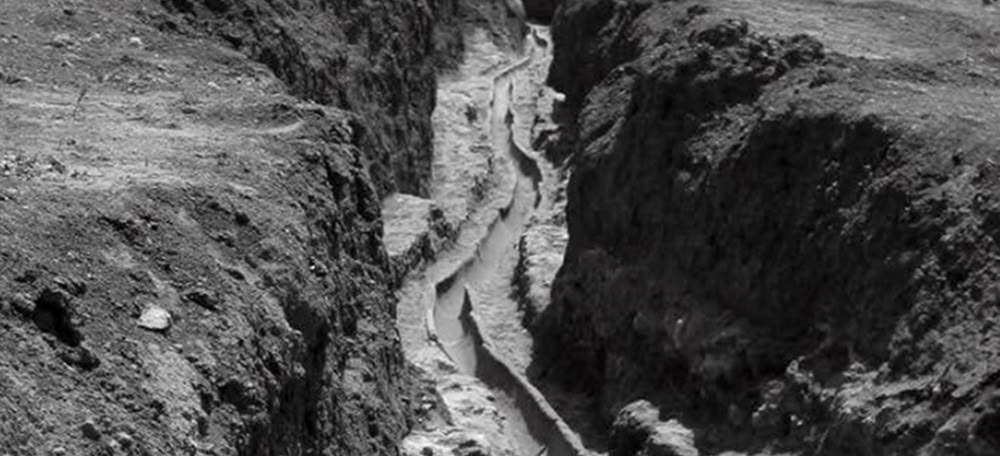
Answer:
top-left (429, 25), bottom-right (584, 456)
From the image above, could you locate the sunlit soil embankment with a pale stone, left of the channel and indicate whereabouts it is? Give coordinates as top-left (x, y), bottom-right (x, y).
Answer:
top-left (0, 0), bottom-right (508, 455)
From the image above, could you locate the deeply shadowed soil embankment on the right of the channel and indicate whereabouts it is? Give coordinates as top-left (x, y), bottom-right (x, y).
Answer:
top-left (534, 0), bottom-right (1000, 455)
